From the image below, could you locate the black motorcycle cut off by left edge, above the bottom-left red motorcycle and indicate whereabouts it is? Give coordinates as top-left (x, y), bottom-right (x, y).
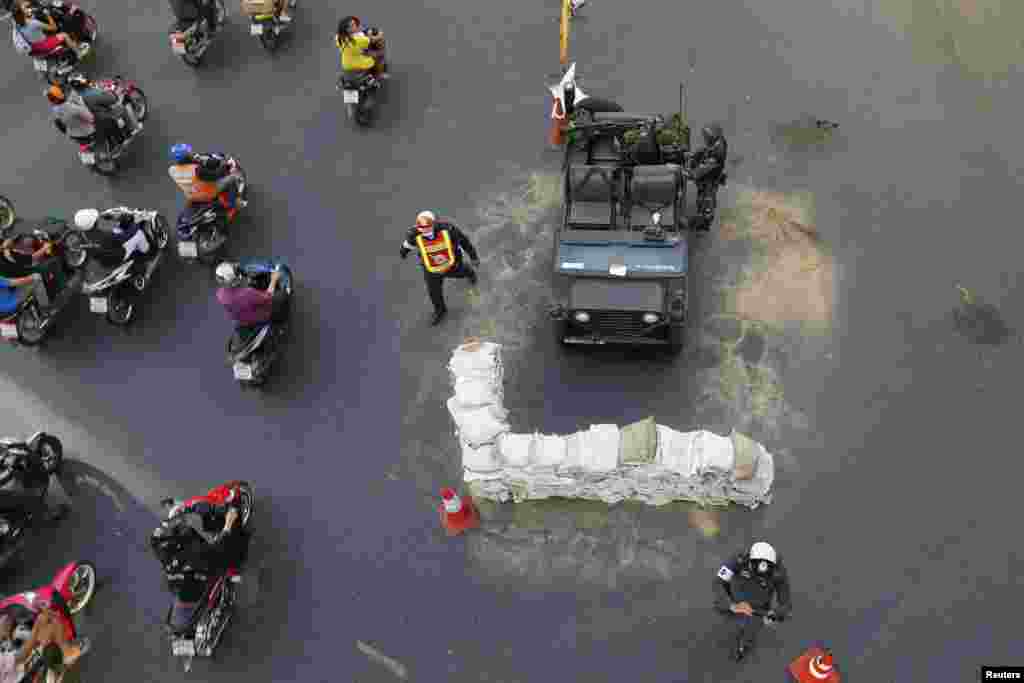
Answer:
top-left (0, 431), bottom-right (63, 566)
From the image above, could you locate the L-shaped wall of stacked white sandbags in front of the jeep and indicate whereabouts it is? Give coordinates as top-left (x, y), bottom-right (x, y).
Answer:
top-left (447, 339), bottom-right (775, 509)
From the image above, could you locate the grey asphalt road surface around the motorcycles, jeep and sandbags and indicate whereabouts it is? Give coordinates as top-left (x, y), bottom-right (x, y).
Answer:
top-left (0, 0), bottom-right (1024, 682)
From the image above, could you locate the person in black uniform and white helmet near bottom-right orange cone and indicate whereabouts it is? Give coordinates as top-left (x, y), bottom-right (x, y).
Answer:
top-left (714, 542), bottom-right (793, 661)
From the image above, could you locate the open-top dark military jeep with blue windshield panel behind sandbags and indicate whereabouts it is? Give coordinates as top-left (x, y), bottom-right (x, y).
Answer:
top-left (551, 112), bottom-right (690, 352)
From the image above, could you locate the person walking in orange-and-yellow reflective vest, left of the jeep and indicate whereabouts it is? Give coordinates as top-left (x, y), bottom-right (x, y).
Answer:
top-left (400, 211), bottom-right (480, 325)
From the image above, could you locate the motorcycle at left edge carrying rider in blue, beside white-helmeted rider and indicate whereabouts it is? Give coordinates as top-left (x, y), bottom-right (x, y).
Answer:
top-left (0, 218), bottom-right (87, 346)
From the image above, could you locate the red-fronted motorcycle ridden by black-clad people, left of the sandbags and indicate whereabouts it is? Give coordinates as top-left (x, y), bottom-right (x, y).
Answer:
top-left (162, 481), bottom-right (255, 671)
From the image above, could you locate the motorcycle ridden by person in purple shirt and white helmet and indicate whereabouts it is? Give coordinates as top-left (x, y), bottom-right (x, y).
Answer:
top-left (226, 260), bottom-right (293, 386)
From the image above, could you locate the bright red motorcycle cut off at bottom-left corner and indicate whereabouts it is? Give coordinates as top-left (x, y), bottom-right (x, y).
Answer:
top-left (0, 562), bottom-right (96, 649)
